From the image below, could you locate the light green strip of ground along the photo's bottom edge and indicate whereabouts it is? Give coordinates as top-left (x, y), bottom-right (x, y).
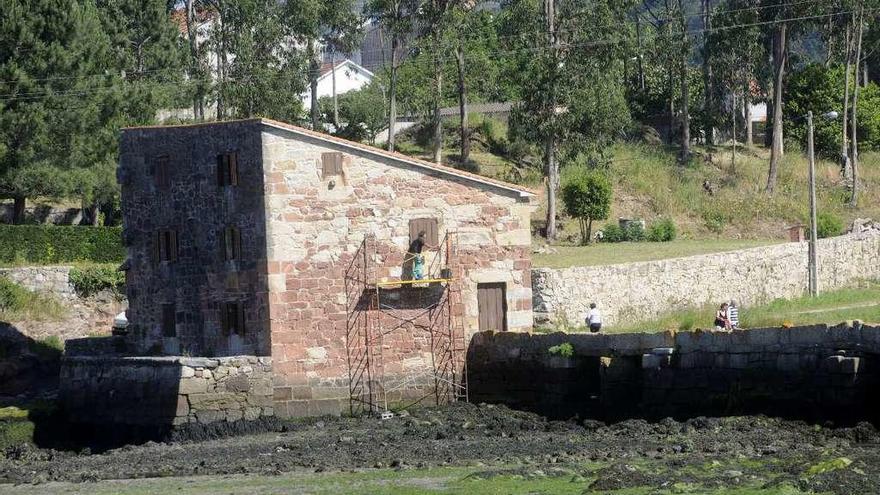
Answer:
top-left (0, 467), bottom-right (820, 495)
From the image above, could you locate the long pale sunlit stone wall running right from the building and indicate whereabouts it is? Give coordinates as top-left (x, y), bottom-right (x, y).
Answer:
top-left (532, 234), bottom-right (880, 325)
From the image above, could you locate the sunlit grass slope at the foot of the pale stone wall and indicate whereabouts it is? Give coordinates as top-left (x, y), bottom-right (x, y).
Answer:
top-left (608, 281), bottom-right (880, 333)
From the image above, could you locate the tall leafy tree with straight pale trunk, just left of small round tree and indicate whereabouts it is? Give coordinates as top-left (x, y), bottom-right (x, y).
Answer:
top-left (501, 0), bottom-right (632, 239)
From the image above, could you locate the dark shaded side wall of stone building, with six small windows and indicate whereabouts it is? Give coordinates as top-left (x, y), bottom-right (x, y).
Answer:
top-left (117, 121), bottom-right (270, 356)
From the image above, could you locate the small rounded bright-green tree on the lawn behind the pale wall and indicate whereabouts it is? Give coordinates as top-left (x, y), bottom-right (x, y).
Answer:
top-left (562, 169), bottom-right (611, 244)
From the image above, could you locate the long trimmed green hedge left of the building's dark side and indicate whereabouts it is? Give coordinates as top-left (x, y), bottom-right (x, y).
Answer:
top-left (0, 225), bottom-right (125, 264)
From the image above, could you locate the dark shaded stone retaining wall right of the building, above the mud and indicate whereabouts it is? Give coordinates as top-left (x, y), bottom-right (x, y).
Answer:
top-left (468, 323), bottom-right (880, 419)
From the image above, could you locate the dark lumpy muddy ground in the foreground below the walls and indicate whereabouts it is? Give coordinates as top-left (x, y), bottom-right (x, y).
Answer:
top-left (0, 404), bottom-right (880, 494)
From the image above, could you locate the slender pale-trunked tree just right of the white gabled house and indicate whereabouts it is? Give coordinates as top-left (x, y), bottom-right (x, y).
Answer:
top-left (364, 0), bottom-right (419, 151)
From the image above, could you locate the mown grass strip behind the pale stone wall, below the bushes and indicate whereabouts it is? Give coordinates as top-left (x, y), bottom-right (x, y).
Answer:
top-left (532, 239), bottom-right (780, 268)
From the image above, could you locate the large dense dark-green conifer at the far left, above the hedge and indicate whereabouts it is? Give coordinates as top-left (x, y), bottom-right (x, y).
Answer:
top-left (0, 0), bottom-right (118, 223)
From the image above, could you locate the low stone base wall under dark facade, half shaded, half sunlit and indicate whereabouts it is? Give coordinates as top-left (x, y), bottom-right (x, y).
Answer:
top-left (60, 356), bottom-right (274, 427)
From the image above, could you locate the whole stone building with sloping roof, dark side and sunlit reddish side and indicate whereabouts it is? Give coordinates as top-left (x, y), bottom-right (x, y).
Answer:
top-left (118, 119), bottom-right (534, 416)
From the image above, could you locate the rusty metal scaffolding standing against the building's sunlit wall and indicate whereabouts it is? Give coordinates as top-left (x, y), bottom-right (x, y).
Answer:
top-left (345, 232), bottom-right (468, 414)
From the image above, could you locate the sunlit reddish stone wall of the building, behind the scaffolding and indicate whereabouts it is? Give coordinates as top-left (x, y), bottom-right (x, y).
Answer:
top-left (263, 124), bottom-right (533, 416)
